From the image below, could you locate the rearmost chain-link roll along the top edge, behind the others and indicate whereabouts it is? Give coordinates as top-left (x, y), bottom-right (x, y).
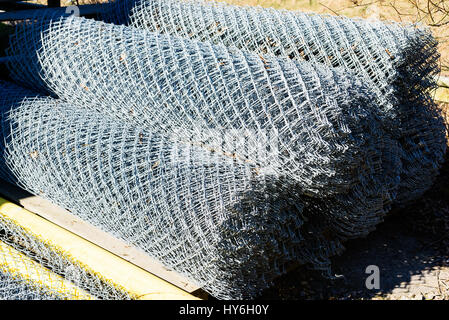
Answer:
top-left (102, 0), bottom-right (438, 105)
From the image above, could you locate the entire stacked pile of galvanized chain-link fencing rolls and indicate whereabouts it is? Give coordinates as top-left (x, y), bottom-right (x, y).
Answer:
top-left (1, 1), bottom-right (445, 298)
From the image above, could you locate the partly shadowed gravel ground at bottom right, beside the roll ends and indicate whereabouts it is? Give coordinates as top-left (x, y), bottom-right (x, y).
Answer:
top-left (261, 210), bottom-right (449, 300)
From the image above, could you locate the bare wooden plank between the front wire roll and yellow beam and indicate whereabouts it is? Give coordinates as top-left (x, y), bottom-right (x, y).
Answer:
top-left (0, 180), bottom-right (199, 293)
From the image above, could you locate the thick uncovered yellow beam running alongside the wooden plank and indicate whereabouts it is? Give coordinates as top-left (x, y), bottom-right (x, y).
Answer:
top-left (0, 197), bottom-right (198, 300)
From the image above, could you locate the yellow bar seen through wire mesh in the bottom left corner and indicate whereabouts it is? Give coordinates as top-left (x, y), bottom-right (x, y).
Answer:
top-left (0, 241), bottom-right (95, 300)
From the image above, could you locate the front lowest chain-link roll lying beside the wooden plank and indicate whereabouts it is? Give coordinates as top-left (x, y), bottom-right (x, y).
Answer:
top-left (2, 80), bottom-right (317, 298)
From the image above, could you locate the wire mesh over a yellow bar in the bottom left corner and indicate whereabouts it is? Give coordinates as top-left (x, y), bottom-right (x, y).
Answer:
top-left (0, 191), bottom-right (135, 300)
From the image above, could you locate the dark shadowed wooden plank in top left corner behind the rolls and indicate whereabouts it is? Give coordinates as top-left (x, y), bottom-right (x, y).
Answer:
top-left (0, 4), bottom-right (107, 21)
